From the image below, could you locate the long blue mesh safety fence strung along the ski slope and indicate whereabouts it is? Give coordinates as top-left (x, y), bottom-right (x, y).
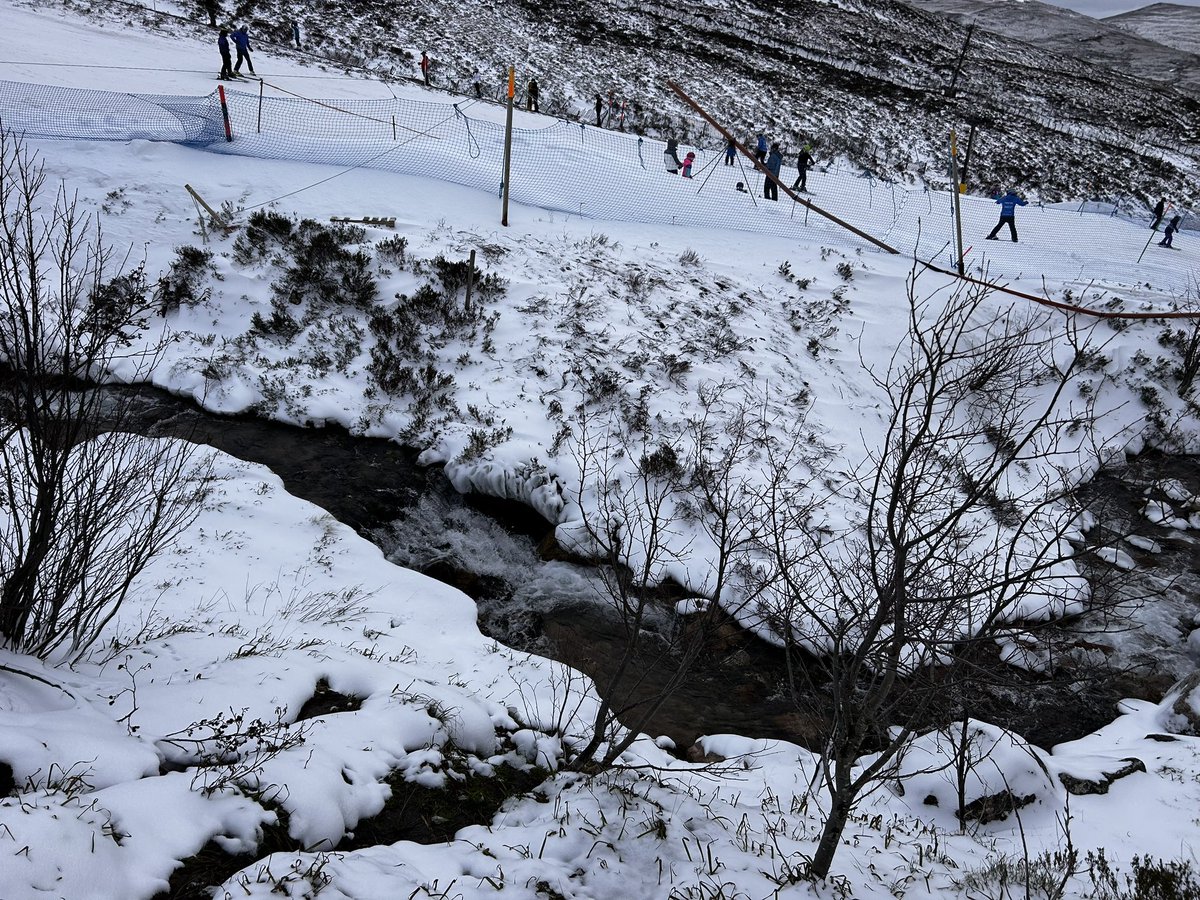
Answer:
top-left (0, 82), bottom-right (1200, 298)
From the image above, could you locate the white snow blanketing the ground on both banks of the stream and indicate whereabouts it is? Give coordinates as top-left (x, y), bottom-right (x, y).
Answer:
top-left (0, 0), bottom-right (1200, 900)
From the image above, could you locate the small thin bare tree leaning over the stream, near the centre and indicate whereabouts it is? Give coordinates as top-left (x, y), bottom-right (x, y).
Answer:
top-left (556, 385), bottom-right (782, 770)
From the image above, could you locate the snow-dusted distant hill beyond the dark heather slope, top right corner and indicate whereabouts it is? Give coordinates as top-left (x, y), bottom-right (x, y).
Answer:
top-left (910, 0), bottom-right (1200, 95)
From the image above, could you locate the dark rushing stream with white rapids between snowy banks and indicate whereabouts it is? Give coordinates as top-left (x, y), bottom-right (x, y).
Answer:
top-left (127, 388), bottom-right (1200, 750)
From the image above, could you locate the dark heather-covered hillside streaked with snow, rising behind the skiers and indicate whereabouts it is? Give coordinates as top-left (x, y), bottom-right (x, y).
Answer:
top-left (16, 0), bottom-right (1198, 206)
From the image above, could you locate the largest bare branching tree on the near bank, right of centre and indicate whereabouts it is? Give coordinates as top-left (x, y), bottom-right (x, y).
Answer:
top-left (761, 275), bottom-right (1113, 877)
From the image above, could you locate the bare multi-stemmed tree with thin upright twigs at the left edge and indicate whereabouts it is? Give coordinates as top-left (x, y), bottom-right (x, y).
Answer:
top-left (0, 130), bottom-right (208, 658)
